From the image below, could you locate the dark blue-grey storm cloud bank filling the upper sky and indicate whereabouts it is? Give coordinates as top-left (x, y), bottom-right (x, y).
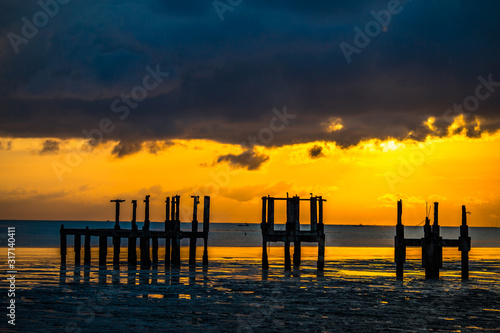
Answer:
top-left (0, 0), bottom-right (500, 148)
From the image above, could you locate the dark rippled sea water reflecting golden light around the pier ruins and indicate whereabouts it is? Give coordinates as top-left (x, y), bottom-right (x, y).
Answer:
top-left (0, 221), bottom-right (500, 332)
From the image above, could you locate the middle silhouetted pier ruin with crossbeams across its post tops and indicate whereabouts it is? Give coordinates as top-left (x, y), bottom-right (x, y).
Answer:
top-left (261, 195), bottom-right (326, 271)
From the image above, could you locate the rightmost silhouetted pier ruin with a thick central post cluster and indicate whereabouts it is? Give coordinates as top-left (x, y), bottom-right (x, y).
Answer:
top-left (394, 200), bottom-right (471, 280)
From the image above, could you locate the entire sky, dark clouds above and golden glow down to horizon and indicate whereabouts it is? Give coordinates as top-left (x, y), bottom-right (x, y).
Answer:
top-left (0, 0), bottom-right (500, 226)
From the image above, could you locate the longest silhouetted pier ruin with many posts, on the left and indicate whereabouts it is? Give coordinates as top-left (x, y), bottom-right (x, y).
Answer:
top-left (60, 195), bottom-right (210, 268)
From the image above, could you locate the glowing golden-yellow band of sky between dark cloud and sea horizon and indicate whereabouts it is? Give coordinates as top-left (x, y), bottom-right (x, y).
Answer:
top-left (0, 115), bottom-right (500, 226)
